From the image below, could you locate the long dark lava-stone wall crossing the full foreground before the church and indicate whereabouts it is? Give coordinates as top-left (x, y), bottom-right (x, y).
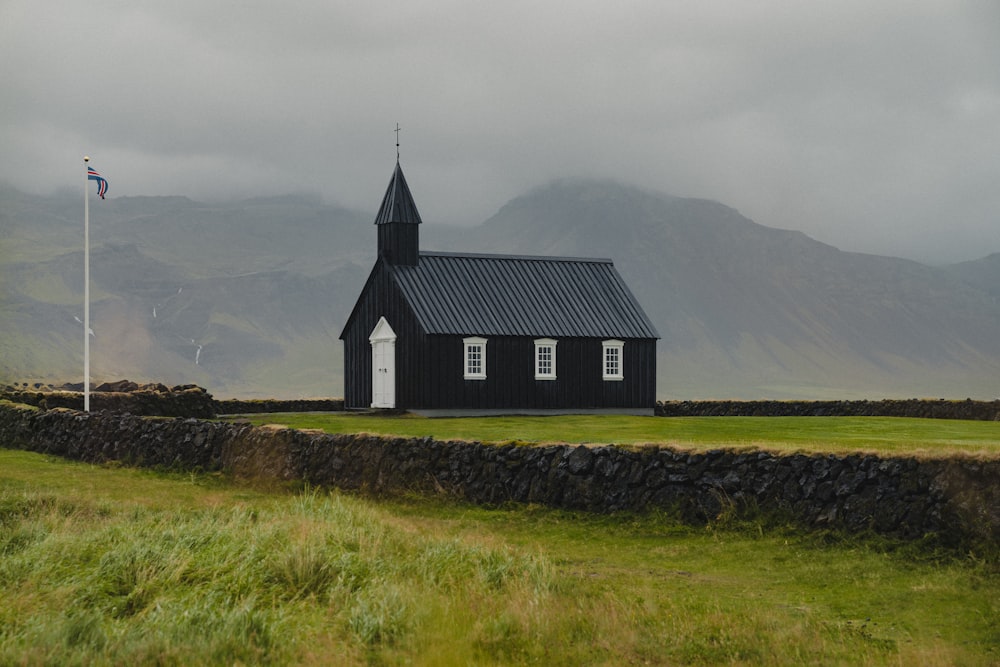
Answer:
top-left (0, 403), bottom-right (1000, 542)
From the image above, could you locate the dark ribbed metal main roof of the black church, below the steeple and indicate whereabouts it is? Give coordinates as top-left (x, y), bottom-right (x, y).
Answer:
top-left (389, 252), bottom-right (659, 338)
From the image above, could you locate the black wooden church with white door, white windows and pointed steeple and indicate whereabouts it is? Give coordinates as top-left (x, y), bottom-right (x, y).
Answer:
top-left (340, 160), bottom-right (658, 414)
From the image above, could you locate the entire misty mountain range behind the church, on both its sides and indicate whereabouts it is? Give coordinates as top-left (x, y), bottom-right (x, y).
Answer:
top-left (0, 181), bottom-right (1000, 399)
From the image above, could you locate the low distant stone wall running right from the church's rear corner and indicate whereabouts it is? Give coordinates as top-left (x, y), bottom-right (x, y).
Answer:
top-left (656, 398), bottom-right (1000, 421)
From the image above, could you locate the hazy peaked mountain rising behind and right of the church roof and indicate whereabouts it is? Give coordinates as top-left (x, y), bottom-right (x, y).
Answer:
top-left (434, 182), bottom-right (1000, 397)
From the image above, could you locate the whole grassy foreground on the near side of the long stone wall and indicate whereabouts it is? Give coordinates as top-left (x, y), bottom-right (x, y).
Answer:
top-left (0, 449), bottom-right (1000, 665)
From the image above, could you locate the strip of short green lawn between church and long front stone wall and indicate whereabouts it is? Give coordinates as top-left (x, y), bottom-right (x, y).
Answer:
top-left (230, 412), bottom-right (1000, 458)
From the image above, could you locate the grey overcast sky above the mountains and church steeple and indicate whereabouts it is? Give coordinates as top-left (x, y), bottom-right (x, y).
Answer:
top-left (0, 0), bottom-right (1000, 261)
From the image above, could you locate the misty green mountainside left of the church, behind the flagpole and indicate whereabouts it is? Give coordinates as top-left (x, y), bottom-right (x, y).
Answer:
top-left (0, 189), bottom-right (374, 397)
